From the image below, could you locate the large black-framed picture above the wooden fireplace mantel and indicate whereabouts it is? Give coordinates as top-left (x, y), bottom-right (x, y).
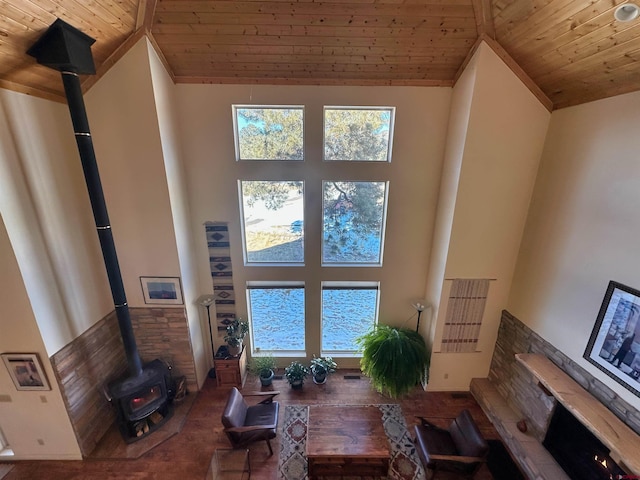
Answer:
top-left (583, 281), bottom-right (640, 397)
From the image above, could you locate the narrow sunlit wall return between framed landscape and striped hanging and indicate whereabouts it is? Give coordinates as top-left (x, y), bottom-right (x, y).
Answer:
top-left (146, 41), bottom-right (208, 386)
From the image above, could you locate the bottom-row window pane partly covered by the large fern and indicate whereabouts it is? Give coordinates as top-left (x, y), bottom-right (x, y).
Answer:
top-left (320, 282), bottom-right (378, 355)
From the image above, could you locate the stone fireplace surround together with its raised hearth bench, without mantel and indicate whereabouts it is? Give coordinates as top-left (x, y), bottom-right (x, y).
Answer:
top-left (471, 310), bottom-right (640, 480)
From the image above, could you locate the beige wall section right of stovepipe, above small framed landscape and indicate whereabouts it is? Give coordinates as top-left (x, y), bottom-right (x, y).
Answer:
top-left (85, 39), bottom-right (183, 308)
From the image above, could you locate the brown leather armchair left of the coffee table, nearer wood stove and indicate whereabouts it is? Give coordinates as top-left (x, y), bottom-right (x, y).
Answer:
top-left (222, 387), bottom-right (280, 455)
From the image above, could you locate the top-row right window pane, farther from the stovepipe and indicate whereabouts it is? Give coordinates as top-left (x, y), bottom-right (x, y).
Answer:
top-left (324, 107), bottom-right (395, 162)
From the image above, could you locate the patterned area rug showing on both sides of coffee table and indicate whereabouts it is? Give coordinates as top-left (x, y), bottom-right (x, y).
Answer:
top-left (277, 404), bottom-right (426, 480)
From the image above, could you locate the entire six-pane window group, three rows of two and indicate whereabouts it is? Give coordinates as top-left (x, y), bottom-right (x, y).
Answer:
top-left (233, 105), bottom-right (395, 357)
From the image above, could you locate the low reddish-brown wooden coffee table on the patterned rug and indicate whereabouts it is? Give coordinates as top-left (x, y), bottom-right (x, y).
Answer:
top-left (307, 405), bottom-right (391, 479)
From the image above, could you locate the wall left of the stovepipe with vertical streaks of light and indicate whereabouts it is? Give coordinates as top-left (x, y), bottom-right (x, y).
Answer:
top-left (0, 90), bottom-right (113, 356)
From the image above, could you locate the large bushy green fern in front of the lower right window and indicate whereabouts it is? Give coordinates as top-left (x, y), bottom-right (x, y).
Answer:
top-left (357, 325), bottom-right (430, 398)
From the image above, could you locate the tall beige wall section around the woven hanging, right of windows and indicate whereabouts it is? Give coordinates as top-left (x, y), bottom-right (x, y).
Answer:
top-left (429, 43), bottom-right (550, 390)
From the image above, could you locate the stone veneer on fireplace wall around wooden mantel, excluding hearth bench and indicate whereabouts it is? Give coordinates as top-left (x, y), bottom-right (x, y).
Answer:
top-left (489, 310), bottom-right (640, 441)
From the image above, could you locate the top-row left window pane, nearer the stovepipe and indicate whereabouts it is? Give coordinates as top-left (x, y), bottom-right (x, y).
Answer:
top-left (233, 105), bottom-right (304, 160)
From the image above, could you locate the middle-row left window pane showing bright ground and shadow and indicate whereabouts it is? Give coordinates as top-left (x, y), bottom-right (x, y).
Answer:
top-left (240, 181), bottom-right (304, 264)
